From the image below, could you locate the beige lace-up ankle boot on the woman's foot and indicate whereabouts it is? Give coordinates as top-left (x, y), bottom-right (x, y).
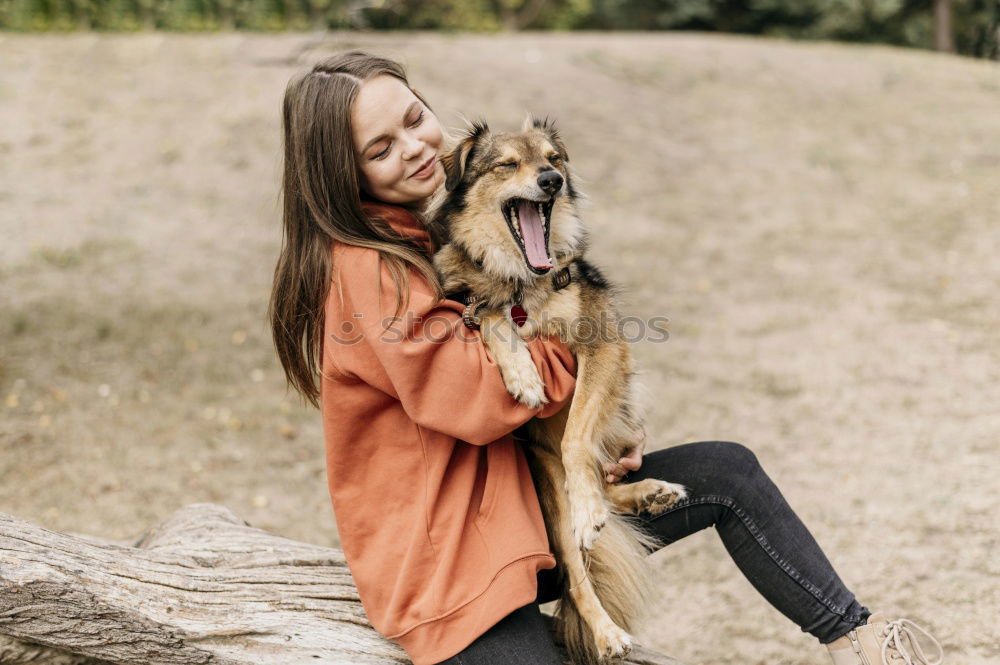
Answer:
top-left (826, 614), bottom-right (944, 665)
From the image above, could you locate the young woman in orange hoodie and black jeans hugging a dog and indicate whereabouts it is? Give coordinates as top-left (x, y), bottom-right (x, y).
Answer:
top-left (269, 51), bottom-right (939, 665)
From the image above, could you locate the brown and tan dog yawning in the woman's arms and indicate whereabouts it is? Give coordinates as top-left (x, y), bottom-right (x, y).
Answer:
top-left (430, 116), bottom-right (685, 663)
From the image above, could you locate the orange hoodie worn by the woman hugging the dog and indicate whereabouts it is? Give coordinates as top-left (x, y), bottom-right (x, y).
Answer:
top-left (321, 204), bottom-right (576, 665)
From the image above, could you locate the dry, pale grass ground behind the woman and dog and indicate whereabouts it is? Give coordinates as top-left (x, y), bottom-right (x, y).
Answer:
top-left (0, 29), bottom-right (1000, 665)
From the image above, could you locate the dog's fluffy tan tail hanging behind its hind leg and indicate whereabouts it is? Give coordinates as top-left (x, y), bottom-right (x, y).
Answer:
top-left (556, 506), bottom-right (657, 665)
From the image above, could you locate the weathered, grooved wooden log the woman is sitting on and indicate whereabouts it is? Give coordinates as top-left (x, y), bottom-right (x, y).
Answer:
top-left (0, 503), bottom-right (680, 665)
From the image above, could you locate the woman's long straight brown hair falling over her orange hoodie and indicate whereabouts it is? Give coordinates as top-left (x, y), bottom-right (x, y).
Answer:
top-left (267, 51), bottom-right (442, 408)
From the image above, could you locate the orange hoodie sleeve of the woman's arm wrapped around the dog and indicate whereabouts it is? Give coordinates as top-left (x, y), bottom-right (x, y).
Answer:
top-left (323, 245), bottom-right (576, 445)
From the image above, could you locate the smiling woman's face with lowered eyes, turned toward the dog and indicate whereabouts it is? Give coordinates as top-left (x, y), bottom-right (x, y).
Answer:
top-left (351, 74), bottom-right (444, 204)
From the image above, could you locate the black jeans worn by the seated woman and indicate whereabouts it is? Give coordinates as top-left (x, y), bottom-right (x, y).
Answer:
top-left (436, 441), bottom-right (871, 665)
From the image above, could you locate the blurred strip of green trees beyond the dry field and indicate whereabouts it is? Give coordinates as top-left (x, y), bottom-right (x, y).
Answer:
top-left (0, 0), bottom-right (1000, 58)
